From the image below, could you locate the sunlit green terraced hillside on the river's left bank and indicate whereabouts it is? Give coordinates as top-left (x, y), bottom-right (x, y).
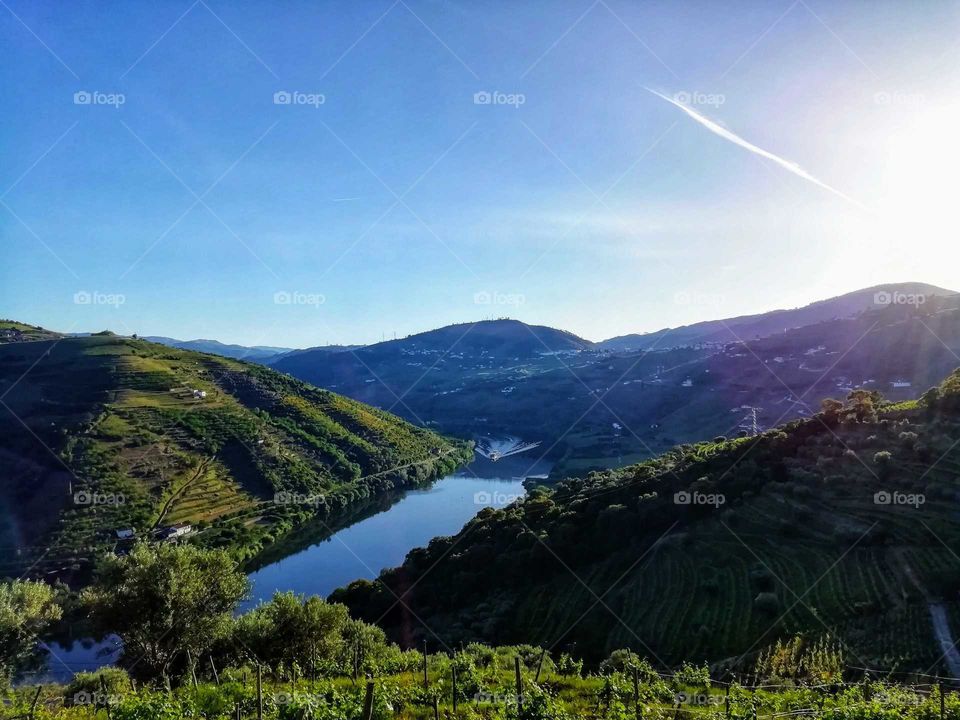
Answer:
top-left (0, 326), bottom-right (471, 574)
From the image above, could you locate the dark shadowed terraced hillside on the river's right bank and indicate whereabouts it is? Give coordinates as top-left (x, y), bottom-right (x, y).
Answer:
top-left (333, 371), bottom-right (960, 672)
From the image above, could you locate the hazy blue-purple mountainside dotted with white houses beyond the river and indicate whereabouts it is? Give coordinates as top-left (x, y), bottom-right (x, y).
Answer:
top-left (274, 284), bottom-right (960, 476)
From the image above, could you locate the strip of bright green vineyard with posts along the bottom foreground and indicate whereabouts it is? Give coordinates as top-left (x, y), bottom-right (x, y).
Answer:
top-left (0, 646), bottom-right (960, 720)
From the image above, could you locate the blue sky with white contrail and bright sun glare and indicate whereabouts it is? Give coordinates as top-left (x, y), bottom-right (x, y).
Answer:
top-left (0, 0), bottom-right (960, 347)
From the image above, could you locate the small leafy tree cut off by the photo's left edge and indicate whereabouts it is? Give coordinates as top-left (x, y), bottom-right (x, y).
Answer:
top-left (0, 580), bottom-right (62, 685)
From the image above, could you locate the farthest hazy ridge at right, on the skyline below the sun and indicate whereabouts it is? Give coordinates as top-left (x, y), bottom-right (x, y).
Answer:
top-left (598, 283), bottom-right (957, 350)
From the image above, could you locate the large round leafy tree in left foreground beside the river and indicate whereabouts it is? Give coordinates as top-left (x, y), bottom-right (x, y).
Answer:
top-left (85, 544), bottom-right (249, 678)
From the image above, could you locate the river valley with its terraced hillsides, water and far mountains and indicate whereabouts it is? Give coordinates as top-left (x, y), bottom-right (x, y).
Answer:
top-left (0, 280), bottom-right (960, 688)
